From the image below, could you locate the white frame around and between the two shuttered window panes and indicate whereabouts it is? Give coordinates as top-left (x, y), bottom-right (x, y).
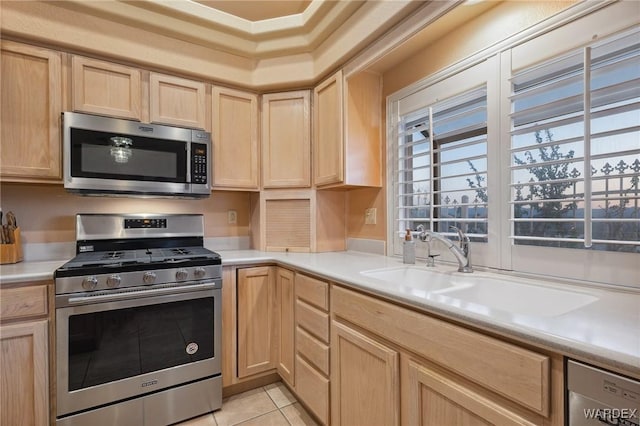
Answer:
top-left (387, 2), bottom-right (640, 288)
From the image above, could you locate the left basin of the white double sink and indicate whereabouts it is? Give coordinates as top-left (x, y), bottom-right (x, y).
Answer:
top-left (360, 266), bottom-right (473, 293)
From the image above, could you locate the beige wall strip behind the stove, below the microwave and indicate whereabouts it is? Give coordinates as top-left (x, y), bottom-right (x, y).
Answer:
top-left (0, 183), bottom-right (250, 243)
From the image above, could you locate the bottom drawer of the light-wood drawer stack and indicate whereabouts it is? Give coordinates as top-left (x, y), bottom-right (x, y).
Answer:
top-left (296, 356), bottom-right (329, 424)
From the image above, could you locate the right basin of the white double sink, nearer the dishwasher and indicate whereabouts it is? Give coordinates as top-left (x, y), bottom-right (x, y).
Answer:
top-left (446, 276), bottom-right (598, 317)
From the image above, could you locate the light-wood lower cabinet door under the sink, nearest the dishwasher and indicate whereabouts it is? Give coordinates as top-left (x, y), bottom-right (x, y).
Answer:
top-left (402, 360), bottom-right (542, 426)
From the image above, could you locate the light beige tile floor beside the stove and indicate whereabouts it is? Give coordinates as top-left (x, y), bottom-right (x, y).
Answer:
top-left (176, 382), bottom-right (317, 426)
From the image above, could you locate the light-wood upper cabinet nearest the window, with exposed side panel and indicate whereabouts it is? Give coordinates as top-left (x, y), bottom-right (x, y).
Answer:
top-left (313, 71), bottom-right (382, 187)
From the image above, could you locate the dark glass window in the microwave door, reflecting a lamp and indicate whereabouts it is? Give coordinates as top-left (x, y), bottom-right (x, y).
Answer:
top-left (71, 129), bottom-right (187, 183)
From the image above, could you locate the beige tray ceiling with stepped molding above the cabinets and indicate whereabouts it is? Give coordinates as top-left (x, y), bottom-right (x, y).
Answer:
top-left (0, 0), bottom-right (500, 90)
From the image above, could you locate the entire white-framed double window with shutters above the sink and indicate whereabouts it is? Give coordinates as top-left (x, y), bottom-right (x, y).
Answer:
top-left (387, 2), bottom-right (640, 288)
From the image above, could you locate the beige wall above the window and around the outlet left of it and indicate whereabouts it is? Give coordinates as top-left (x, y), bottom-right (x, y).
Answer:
top-left (347, 0), bottom-right (576, 245)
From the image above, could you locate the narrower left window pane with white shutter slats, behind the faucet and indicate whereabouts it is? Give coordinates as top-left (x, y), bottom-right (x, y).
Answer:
top-left (395, 86), bottom-right (488, 242)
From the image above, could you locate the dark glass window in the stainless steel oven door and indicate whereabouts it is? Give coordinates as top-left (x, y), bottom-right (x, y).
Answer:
top-left (69, 297), bottom-right (214, 391)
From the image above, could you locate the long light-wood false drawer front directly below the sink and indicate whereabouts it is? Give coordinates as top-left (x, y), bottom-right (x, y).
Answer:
top-left (331, 286), bottom-right (551, 416)
